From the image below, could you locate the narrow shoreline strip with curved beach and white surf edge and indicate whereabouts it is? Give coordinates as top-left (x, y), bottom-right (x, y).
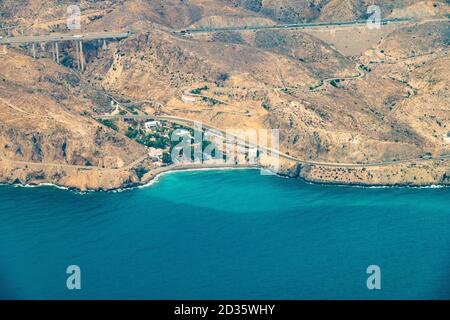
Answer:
top-left (0, 164), bottom-right (450, 194)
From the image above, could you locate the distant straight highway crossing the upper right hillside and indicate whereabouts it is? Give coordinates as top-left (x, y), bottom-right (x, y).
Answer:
top-left (174, 18), bottom-right (413, 35)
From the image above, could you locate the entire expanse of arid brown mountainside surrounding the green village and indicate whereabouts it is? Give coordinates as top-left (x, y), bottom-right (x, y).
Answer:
top-left (0, 0), bottom-right (450, 189)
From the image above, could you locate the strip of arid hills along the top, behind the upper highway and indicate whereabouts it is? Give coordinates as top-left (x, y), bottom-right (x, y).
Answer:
top-left (0, 0), bottom-right (449, 29)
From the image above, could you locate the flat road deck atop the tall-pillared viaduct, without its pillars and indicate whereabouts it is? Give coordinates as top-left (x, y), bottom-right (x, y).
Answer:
top-left (0, 32), bottom-right (130, 44)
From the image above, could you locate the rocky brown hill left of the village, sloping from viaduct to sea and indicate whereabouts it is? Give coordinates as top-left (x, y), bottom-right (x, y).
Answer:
top-left (0, 50), bottom-right (146, 188)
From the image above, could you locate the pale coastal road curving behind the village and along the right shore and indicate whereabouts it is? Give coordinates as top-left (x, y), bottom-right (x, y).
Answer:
top-left (95, 115), bottom-right (450, 168)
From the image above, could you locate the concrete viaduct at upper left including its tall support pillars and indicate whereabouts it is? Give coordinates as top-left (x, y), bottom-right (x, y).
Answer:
top-left (0, 32), bottom-right (130, 71)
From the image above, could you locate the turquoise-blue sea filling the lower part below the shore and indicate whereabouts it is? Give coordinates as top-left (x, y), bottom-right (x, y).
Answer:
top-left (0, 170), bottom-right (450, 299)
